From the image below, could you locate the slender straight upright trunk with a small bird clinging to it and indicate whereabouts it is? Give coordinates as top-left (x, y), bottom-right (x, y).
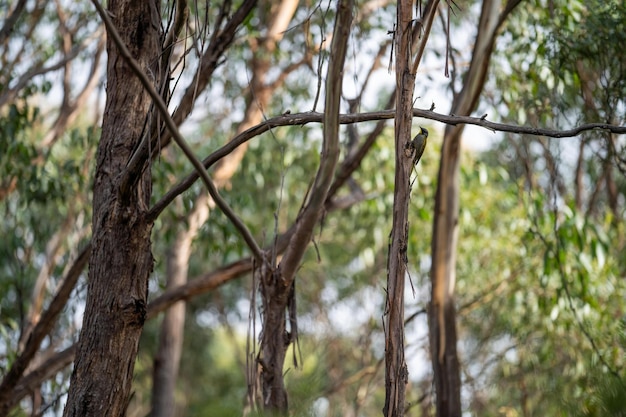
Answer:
top-left (383, 1), bottom-right (415, 417)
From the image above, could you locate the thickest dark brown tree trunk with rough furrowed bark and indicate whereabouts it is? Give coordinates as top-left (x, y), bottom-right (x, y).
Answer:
top-left (64, 0), bottom-right (161, 417)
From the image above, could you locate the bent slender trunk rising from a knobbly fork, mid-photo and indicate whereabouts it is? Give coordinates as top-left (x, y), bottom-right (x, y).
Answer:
top-left (259, 0), bottom-right (353, 415)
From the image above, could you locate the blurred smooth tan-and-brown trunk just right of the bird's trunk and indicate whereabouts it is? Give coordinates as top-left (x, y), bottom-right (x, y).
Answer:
top-left (429, 0), bottom-right (519, 417)
